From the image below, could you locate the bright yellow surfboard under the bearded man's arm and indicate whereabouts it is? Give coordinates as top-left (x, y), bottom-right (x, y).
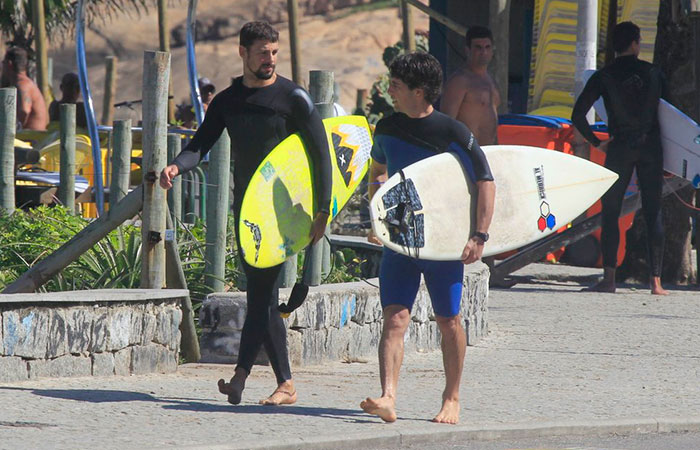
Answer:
top-left (239, 116), bottom-right (372, 268)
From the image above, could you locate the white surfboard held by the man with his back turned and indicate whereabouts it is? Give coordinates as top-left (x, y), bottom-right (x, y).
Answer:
top-left (583, 70), bottom-right (700, 189)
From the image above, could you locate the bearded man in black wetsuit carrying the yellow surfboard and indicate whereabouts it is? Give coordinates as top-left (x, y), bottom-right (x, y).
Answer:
top-left (160, 22), bottom-right (331, 405)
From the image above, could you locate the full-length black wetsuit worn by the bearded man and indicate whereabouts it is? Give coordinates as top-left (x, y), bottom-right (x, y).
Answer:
top-left (172, 75), bottom-right (331, 383)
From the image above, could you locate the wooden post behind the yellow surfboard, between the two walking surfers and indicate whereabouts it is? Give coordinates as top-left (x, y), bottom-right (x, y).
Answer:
top-left (303, 70), bottom-right (333, 286)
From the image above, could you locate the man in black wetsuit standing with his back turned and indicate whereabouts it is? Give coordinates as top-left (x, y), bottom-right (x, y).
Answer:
top-left (571, 22), bottom-right (668, 295)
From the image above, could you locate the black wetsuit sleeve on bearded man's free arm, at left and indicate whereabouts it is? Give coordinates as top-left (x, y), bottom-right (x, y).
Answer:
top-left (170, 96), bottom-right (226, 175)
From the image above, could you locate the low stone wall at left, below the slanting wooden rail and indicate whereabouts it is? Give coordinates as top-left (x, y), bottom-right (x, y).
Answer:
top-left (0, 289), bottom-right (187, 381)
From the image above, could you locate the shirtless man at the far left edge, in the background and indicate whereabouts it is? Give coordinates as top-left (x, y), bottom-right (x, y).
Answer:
top-left (2, 47), bottom-right (49, 131)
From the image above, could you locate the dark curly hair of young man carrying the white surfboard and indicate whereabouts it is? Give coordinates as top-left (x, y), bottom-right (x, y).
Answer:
top-left (389, 52), bottom-right (442, 104)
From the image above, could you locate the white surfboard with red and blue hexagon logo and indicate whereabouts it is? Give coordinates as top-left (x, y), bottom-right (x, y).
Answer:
top-left (370, 145), bottom-right (617, 261)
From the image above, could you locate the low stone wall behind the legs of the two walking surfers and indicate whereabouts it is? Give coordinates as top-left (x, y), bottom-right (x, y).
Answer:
top-left (199, 263), bottom-right (489, 366)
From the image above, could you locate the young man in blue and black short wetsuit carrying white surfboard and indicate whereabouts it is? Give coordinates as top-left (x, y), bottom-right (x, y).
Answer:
top-left (360, 53), bottom-right (496, 424)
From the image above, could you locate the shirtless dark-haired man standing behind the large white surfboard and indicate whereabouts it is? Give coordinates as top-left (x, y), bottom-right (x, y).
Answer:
top-left (440, 26), bottom-right (501, 145)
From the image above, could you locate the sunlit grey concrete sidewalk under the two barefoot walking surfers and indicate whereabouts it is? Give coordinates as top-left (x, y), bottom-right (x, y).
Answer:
top-left (0, 264), bottom-right (700, 449)
